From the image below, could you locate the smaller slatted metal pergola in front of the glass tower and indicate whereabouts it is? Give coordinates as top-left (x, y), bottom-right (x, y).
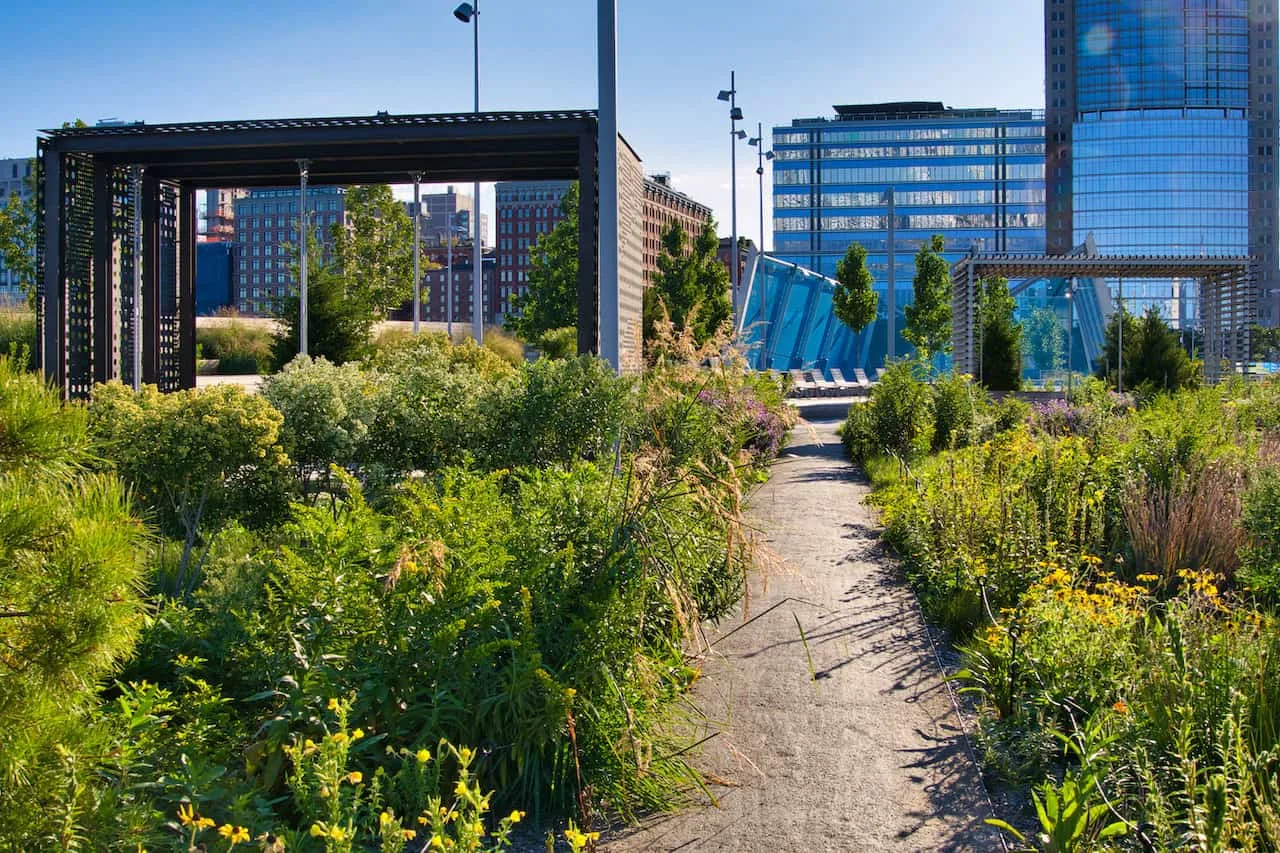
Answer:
top-left (951, 254), bottom-right (1257, 382)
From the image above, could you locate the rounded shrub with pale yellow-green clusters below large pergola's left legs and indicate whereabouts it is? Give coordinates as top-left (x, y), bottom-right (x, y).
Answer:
top-left (90, 382), bottom-right (288, 596)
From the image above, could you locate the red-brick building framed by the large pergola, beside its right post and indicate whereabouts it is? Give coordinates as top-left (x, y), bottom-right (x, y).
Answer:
top-left (489, 181), bottom-right (570, 324)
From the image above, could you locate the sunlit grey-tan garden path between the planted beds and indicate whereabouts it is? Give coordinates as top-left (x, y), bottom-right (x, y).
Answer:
top-left (604, 409), bottom-right (1001, 853)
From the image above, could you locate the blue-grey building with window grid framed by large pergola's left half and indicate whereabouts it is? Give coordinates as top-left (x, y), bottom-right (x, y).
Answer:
top-left (233, 186), bottom-right (347, 315)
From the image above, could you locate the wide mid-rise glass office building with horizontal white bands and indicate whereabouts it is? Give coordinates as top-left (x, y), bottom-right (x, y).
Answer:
top-left (771, 101), bottom-right (1044, 368)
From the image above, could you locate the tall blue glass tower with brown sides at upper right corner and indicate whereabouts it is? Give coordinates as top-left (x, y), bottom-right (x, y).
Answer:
top-left (1044, 0), bottom-right (1280, 325)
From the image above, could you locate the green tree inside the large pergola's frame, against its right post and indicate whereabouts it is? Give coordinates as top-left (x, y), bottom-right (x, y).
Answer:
top-left (507, 182), bottom-right (579, 346)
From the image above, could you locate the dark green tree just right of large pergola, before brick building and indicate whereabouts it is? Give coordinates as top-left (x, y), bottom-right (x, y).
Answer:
top-left (644, 222), bottom-right (733, 346)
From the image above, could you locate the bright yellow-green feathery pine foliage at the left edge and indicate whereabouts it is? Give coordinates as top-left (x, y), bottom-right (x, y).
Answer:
top-left (0, 357), bottom-right (146, 849)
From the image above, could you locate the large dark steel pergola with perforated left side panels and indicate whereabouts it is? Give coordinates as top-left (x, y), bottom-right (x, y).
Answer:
top-left (37, 110), bottom-right (599, 397)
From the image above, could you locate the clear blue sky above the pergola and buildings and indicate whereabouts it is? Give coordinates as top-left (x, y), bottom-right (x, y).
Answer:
top-left (0, 0), bottom-right (1044, 247)
